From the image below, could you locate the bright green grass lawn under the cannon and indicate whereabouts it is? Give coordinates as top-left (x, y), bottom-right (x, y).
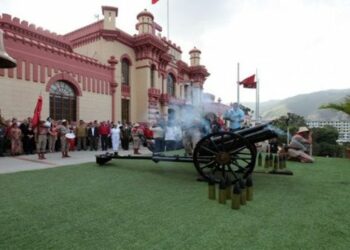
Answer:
top-left (0, 158), bottom-right (350, 250)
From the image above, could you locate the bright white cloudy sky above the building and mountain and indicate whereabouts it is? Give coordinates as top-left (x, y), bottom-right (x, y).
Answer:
top-left (0, 0), bottom-right (350, 103)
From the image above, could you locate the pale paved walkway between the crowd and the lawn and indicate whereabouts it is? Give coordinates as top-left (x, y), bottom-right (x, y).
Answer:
top-left (0, 148), bottom-right (150, 174)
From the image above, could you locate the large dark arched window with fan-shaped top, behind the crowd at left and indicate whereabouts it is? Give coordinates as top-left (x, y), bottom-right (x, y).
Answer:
top-left (50, 81), bottom-right (77, 121)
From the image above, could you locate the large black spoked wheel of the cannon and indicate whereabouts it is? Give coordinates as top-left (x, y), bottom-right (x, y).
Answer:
top-left (193, 132), bottom-right (257, 183)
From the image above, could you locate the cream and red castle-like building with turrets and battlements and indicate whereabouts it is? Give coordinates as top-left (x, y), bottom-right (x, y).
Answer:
top-left (0, 6), bottom-right (209, 122)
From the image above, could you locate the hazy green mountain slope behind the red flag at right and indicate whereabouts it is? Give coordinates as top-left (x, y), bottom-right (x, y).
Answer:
top-left (243, 89), bottom-right (350, 121)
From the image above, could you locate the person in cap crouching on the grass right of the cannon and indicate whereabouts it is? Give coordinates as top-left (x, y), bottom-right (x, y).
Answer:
top-left (288, 127), bottom-right (314, 163)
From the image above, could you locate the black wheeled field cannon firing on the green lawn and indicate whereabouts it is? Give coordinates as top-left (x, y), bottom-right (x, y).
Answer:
top-left (96, 124), bottom-right (278, 183)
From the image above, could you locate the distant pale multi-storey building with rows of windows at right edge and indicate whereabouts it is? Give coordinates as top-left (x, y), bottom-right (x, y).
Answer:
top-left (306, 121), bottom-right (350, 143)
